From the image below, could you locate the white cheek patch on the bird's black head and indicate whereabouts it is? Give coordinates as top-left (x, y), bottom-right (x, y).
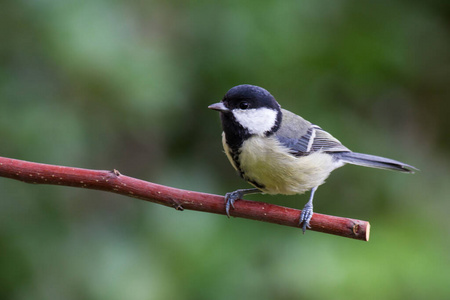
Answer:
top-left (233, 107), bottom-right (277, 135)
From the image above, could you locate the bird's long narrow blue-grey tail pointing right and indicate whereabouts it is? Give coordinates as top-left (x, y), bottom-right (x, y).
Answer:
top-left (335, 152), bottom-right (418, 173)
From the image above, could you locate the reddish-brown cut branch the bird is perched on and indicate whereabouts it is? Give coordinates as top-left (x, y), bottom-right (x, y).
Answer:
top-left (0, 157), bottom-right (370, 241)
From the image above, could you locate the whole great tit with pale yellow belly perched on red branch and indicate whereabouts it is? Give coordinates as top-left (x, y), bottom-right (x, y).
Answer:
top-left (208, 84), bottom-right (417, 233)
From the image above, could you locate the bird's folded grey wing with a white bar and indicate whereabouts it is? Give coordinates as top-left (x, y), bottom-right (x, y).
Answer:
top-left (275, 109), bottom-right (350, 156)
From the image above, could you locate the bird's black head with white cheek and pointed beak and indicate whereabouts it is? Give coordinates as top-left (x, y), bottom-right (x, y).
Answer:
top-left (209, 84), bottom-right (282, 150)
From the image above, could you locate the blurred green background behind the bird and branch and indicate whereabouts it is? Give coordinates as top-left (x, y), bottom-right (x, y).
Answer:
top-left (0, 0), bottom-right (450, 300)
